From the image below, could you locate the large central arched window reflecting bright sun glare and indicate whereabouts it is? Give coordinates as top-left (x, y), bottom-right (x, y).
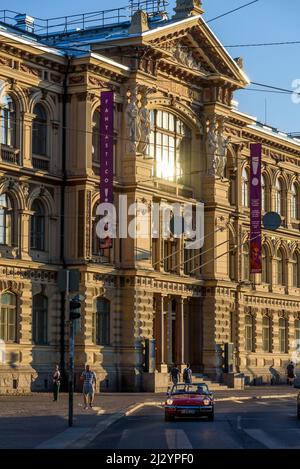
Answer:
top-left (149, 110), bottom-right (191, 182)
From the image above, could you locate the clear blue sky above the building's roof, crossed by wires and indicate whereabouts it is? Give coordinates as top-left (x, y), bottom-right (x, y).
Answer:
top-left (1, 0), bottom-right (300, 132)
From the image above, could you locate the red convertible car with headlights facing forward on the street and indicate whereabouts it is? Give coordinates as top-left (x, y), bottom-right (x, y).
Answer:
top-left (165, 383), bottom-right (214, 422)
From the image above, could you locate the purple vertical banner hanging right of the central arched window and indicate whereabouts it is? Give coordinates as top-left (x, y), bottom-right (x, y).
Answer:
top-left (250, 143), bottom-right (262, 274)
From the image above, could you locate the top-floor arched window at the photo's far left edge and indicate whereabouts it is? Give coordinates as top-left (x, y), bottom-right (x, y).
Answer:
top-left (0, 95), bottom-right (16, 148)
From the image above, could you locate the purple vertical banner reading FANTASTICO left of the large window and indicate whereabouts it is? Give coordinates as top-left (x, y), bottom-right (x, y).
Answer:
top-left (100, 91), bottom-right (114, 249)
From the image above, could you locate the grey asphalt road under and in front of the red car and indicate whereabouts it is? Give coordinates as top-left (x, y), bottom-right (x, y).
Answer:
top-left (89, 398), bottom-right (300, 449)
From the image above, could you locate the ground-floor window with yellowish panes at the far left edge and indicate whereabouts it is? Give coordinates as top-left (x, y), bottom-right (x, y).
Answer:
top-left (0, 292), bottom-right (17, 342)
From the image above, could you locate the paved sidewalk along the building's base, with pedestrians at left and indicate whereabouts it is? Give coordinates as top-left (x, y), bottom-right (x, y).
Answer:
top-left (0, 386), bottom-right (299, 449)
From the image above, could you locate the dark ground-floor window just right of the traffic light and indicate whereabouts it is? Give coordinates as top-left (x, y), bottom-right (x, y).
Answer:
top-left (92, 298), bottom-right (110, 345)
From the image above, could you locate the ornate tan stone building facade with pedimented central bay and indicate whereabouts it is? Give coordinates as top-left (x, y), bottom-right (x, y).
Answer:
top-left (0, 0), bottom-right (300, 392)
